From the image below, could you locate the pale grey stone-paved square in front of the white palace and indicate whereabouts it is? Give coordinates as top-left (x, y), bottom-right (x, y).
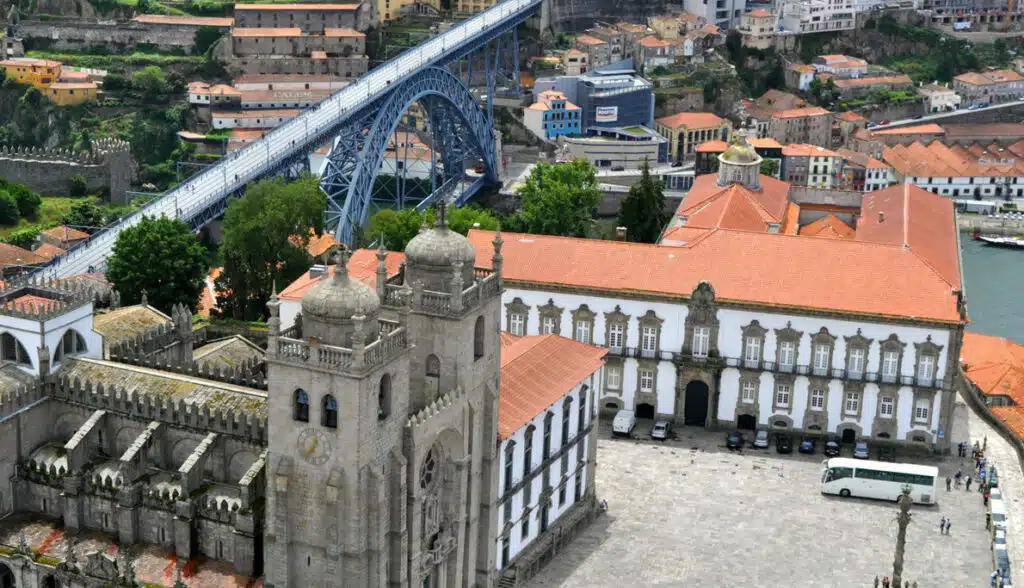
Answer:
top-left (528, 422), bottom-right (992, 588)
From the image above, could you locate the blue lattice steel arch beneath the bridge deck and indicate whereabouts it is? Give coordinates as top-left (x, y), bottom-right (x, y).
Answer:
top-left (321, 68), bottom-right (498, 242)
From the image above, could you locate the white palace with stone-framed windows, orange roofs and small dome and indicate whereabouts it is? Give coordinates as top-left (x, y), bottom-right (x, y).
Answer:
top-left (469, 128), bottom-right (967, 451)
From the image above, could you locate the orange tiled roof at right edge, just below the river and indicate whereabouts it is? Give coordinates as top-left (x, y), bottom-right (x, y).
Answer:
top-left (961, 331), bottom-right (1024, 405)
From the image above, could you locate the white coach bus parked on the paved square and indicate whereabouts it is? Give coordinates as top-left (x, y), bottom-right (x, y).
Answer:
top-left (821, 457), bottom-right (939, 504)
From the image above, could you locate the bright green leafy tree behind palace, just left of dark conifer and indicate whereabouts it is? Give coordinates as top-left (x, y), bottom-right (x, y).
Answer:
top-left (512, 159), bottom-right (601, 237)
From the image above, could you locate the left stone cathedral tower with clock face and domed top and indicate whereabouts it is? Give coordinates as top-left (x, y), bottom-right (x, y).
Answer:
top-left (264, 253), bottom-right (409, 588)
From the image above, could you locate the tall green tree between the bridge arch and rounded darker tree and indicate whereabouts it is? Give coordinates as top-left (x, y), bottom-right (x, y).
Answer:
top-left (217, 174), bottom-right (327, 321)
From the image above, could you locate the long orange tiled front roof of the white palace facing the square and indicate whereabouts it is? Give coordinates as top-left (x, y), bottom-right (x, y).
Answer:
top-left (469, 228), bottom-right (962, 324)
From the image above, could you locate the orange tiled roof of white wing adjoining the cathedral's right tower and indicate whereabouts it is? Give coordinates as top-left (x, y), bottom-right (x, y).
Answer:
top-left (498, 335), bottom-right (608, 440)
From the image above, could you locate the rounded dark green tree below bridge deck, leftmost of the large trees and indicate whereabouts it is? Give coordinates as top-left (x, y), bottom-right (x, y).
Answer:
top-left (106, 216), bottom-right (208, 312)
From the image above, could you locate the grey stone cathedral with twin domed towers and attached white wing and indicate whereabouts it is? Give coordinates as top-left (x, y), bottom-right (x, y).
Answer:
top-left (0, 210), bottom-right (607, 588)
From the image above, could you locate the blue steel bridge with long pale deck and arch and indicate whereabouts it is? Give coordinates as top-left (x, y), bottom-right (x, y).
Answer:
top-left (38, 0), bottom-right (542, 277)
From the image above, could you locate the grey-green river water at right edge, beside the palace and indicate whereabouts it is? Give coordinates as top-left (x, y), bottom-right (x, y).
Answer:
top-left (961, 233), bottom-right (1024, 343)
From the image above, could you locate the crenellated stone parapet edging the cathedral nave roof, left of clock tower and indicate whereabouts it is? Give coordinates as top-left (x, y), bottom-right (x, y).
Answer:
top-left (53, 377), bottom-right (266, 445)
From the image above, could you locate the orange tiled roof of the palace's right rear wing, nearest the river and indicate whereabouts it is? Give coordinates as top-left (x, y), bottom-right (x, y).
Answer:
top-left (857, 183), bottom-right (961, 290)
